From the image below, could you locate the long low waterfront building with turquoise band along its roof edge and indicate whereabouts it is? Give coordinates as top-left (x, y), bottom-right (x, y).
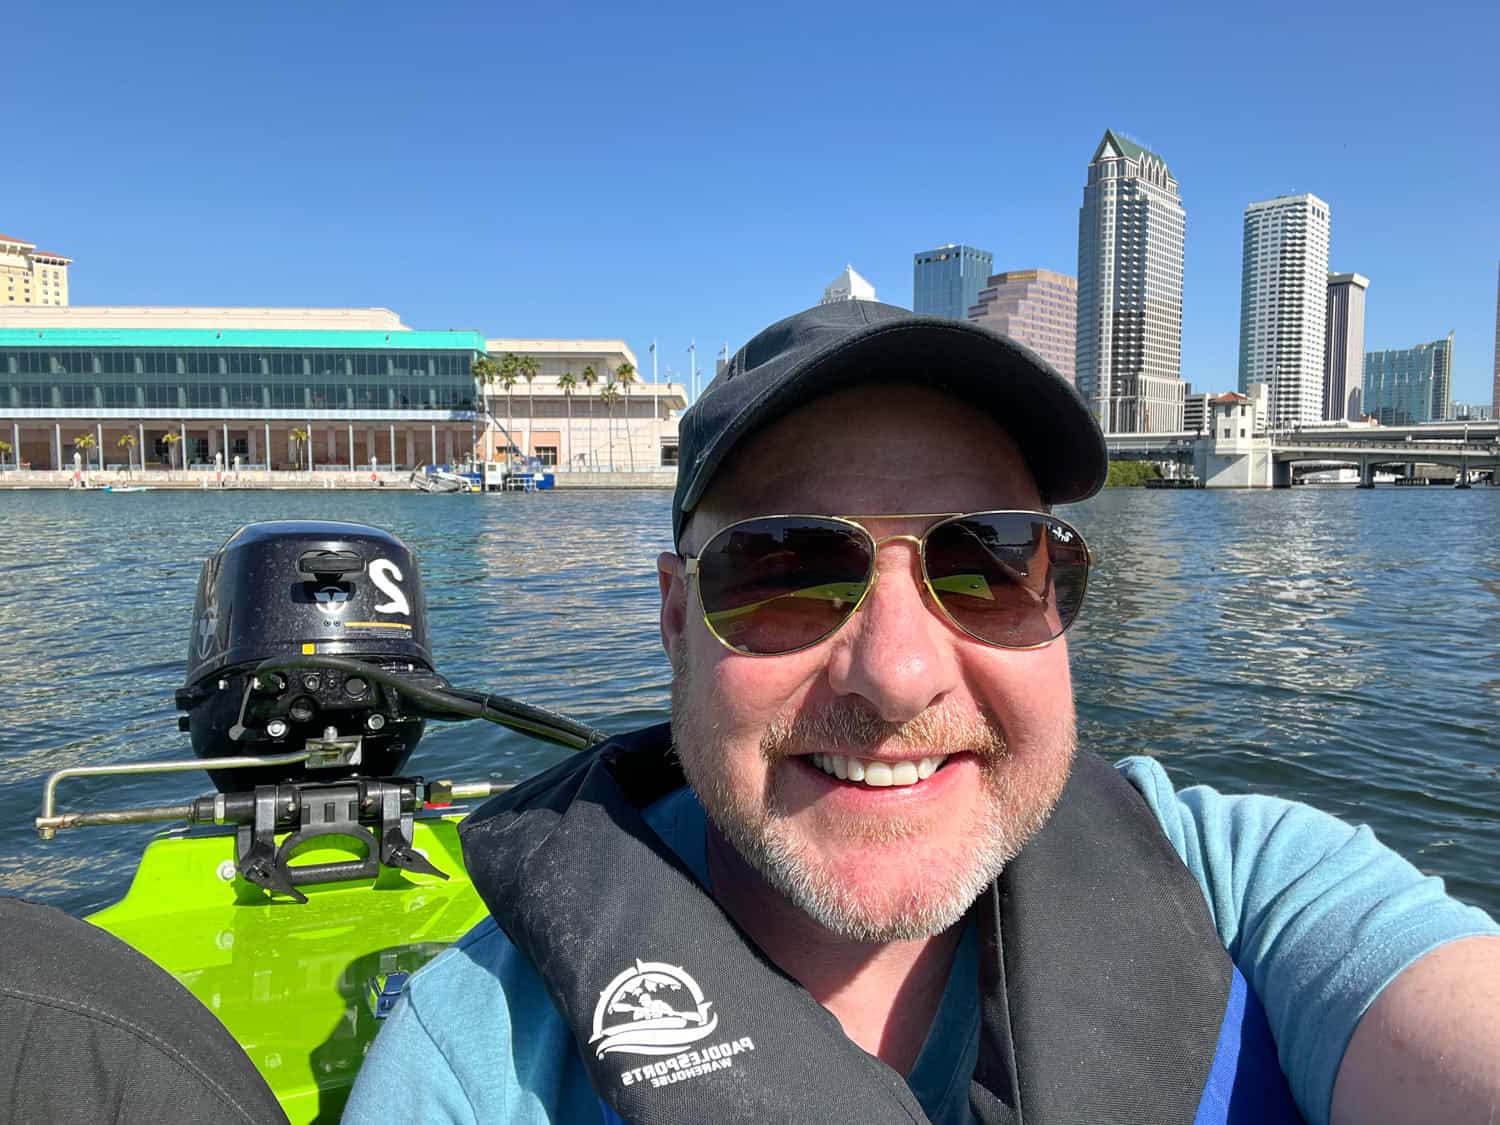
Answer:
top-left (0, 306), bottom-right (485, 470)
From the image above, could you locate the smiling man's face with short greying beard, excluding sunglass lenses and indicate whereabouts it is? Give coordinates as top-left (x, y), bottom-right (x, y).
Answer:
top-left (660, 387), bottom-right (1074, 942)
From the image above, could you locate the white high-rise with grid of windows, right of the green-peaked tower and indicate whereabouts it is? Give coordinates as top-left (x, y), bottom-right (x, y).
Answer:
top-left (1239, 192), bottom-right (1329, 428)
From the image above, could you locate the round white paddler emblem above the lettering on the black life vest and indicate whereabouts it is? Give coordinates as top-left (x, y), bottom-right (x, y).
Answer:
top-left (590, 959), bottom-right (719, 1059)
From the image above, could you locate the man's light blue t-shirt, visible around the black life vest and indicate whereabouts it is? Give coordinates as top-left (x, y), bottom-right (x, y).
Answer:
top-left (344, 758), bottom-right (1500, 1125)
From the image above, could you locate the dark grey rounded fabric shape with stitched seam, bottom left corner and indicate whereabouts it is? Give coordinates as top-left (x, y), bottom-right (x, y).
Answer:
top-left (0, 896), bottom-right (287, 1125)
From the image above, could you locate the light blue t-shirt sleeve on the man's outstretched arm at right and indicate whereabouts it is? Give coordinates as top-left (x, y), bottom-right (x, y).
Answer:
top-left (1118, 758), bottom-right (1500, 1125)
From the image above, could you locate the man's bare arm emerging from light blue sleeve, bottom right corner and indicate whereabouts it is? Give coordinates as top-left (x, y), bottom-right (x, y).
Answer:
top-left (1332, 938), bottom-right (1500, 1125)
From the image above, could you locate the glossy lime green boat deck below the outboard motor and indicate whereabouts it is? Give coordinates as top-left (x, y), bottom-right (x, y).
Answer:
top-left (89, 818), bottom-right (486, 1125)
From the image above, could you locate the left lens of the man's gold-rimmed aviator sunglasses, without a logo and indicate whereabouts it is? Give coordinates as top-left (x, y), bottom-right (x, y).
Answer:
top-left (698, 516), bottom-right (872, 656)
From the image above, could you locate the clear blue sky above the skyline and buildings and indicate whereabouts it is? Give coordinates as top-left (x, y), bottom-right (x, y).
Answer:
top-left (11, 0), bottom-right (1500, 402)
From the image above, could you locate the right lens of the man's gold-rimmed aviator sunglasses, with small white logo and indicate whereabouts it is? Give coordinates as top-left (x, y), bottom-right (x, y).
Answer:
top-left (926, 512), bottom-right (1089, 648)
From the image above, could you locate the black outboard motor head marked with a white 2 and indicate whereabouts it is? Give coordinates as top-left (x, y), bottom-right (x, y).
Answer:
top-left (177, 521), bottom-right (447, 792)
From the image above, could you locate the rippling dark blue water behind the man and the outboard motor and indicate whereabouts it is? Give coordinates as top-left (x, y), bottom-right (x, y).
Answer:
top-left (0, 488), bottom-right (1500, 914)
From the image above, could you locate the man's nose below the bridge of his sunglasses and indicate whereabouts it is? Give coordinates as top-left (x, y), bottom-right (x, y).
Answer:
top-left (827, 540), bottom-right (959, 723)
